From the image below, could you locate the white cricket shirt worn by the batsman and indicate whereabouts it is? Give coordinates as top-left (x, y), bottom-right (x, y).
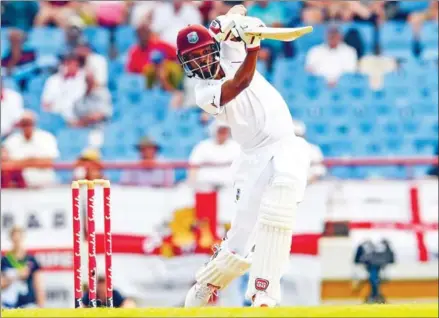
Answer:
top-left (195, 41), bottom-right (294, 153)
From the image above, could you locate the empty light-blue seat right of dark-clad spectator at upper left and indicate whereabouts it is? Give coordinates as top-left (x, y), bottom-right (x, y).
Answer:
top-left (28, 27), bottom-right (65, 55)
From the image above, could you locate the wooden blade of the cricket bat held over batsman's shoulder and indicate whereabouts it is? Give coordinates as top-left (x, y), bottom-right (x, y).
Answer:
top-left (245, 26), bottom-right (313, 42)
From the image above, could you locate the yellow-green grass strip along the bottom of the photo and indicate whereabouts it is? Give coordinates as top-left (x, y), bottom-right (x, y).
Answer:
top-left (1, 304), bottom-right (439, 318)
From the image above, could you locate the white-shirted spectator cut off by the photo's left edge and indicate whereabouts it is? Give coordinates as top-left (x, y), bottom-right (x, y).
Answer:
top-left (0, 80), bottom-right (24, 138)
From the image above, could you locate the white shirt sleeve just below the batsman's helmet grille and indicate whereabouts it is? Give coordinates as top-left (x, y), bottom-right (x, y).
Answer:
top-left (195, 81), bottom-right (224, 115)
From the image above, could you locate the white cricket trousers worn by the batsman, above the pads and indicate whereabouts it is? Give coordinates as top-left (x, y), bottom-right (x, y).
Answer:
top-left (222, 135), bottom-right (310, 257)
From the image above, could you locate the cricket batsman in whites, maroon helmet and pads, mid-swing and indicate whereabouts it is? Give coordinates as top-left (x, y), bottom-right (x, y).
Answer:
top-left (177, 6), bottom-right (310, 307)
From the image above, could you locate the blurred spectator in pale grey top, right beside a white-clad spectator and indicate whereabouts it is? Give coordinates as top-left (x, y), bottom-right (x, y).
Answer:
top-left (69, 73), bottom-right (112, 127)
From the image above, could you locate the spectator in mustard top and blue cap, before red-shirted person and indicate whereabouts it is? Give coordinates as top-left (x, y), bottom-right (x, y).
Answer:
top-left (144, 51), bottom-right (184, 92)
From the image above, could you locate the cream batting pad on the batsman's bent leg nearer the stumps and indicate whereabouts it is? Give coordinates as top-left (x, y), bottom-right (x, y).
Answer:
top-left (196, 249), bottom-right (251, 289)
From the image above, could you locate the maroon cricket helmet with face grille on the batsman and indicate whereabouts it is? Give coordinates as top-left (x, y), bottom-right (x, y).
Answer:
top-left (177, 24), bottom-right (220, 79)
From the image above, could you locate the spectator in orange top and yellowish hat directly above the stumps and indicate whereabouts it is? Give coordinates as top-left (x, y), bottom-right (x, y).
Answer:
top-left (73, 148), bottom-right (105, 180)
